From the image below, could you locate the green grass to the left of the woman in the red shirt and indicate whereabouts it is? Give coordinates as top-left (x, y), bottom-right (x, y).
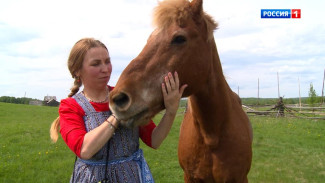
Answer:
top-left (0, 103), bottom-right (74, 183)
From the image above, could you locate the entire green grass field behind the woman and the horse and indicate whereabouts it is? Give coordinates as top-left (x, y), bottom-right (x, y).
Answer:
top-left (0, 103), bottom-right (325, 183)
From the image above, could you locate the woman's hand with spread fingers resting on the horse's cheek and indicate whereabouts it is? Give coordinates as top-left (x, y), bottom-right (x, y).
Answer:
top-left (162, 72), bottom-right (187, 114)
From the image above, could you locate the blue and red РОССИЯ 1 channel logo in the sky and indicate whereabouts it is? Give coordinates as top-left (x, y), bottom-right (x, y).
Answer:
top-left (261, 9), bottom-right (301, 18)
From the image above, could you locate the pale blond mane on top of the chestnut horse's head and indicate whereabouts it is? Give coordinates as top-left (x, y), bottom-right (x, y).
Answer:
top-left (153, 0), bottom-right (218, 40)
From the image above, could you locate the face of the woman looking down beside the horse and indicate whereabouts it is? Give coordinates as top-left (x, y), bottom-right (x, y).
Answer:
top-left (80, 47), bottom-right (112, 89)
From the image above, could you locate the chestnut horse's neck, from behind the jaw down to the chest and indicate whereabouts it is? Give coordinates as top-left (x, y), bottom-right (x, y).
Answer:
top-left (189, 40), bottom-right (232, 146)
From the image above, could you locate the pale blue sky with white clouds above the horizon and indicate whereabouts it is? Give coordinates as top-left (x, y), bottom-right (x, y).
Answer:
top-left (0, 0), bottom-right (325, 100)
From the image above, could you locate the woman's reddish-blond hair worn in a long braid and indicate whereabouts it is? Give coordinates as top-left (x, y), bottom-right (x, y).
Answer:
top-left (50, 38), bottom-right (108, 142)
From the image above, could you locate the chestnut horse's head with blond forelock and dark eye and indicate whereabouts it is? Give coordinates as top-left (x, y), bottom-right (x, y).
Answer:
top-left (110, 0), bottom-right (217, 127)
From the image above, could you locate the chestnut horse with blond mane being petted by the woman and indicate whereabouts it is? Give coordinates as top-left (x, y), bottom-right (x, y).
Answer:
top-left (110, 0), bottom-right (252, 183)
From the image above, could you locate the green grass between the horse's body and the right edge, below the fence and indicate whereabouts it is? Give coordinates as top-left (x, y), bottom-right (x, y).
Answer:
top-left (249, 117), bottom-right (325, 183)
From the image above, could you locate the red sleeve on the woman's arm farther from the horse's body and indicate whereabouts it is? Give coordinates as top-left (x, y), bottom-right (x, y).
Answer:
top-left (59, 98), bottom-right (87, 157)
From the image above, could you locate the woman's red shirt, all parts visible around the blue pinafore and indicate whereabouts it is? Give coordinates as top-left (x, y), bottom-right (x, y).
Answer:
top-left (59, 93), bottom-right (156, 157)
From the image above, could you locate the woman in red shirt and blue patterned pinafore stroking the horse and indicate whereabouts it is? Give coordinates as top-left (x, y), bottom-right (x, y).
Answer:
top-left (51, 38), bottom-right (187, 183)
